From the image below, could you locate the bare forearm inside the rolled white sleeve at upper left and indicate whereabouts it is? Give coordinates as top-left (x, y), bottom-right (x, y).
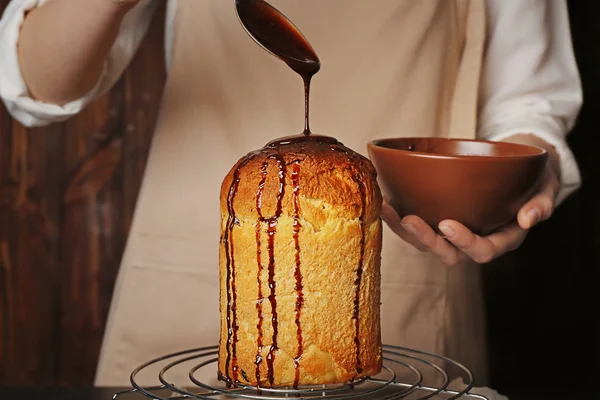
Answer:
top-left (19, 0), bottom-right (136, 105)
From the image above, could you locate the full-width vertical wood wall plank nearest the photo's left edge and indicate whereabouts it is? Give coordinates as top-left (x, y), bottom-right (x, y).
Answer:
top-left (8, 122), bottom-right (62, 384)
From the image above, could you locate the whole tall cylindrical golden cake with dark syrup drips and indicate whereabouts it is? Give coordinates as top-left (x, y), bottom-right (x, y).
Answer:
top-left (219, 135), bottom-right (382, 386)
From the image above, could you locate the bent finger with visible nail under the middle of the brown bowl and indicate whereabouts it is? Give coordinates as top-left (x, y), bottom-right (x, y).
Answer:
top-left (439, 220), bottom-right (528, 264)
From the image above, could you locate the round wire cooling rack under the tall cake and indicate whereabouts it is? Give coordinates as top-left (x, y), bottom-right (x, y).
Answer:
top-left (113, 345), bottom-right (488, 400)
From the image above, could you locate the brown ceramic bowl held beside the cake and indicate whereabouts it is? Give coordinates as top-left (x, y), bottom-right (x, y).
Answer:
top-left (367, 138), bottom-right (548, 235)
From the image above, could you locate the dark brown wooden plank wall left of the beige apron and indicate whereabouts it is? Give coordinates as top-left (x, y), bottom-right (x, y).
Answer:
top-left (0, 0), bottom-right (165, 385)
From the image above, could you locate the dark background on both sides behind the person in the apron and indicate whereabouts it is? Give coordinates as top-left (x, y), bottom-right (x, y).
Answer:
top-left (0, 0), bottom-right (600, 393)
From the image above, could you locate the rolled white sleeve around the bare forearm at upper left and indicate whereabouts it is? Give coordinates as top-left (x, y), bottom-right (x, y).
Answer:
top-left (0, 0), bottom-right (162, 127)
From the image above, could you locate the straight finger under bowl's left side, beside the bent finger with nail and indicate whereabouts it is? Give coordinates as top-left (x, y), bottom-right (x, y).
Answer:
top-left (402, 215), bottom-right (463, 266)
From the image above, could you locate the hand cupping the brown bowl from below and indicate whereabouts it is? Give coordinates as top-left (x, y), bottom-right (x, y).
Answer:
top-left (382, 135), bottom-right (560, 266)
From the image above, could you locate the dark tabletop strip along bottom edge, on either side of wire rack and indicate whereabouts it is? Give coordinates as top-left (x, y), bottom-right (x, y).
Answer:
top-left (0, 387), bottom-right (600, 400)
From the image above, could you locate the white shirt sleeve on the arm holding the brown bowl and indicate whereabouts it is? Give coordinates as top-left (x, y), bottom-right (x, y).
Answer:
top-left (478, 0), bottom-right (582, 204)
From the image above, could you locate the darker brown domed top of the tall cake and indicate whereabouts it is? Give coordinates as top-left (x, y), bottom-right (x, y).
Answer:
top-left (221, 135), bottom-right (382, 225)
